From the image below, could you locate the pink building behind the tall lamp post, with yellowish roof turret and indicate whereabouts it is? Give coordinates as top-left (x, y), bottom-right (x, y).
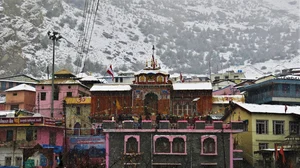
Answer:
top-left (36, 69), bottom-right (90, 119)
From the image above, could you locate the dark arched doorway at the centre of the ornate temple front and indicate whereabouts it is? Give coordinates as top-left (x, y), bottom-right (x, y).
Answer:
top-left (144, 92), bottom-right (158, 114)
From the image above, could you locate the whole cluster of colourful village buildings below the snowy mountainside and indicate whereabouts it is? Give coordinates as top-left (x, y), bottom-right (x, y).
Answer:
top-left (0, 56), bottom-right (300, 168)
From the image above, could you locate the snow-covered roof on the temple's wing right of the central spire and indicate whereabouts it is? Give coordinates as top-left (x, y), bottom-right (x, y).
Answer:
top-left (173, 82), bottom-right (212, 90)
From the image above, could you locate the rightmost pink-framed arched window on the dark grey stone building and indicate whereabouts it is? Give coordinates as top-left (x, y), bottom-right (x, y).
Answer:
top-left (201, 135), bottom-right (217, 155)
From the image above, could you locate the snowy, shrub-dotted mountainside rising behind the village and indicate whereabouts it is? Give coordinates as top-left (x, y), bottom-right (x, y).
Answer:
top-left (0, 0), bottom-right (300, 78)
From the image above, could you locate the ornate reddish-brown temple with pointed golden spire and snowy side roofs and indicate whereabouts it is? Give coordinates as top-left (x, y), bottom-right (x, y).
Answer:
top-left (90, 57), bottom-right (212, 120)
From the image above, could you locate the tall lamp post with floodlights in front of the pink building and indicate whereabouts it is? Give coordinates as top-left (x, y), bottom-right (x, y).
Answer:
top-left (47, 31), bottom-right (62, 117)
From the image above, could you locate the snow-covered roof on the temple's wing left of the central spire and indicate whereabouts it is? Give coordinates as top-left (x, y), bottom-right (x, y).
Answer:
top-left (90, 84), bottom-right (131, 92)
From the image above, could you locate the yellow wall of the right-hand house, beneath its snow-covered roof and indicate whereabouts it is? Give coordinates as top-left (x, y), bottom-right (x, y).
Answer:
top-left (225, 107), bottom-right (294, 165)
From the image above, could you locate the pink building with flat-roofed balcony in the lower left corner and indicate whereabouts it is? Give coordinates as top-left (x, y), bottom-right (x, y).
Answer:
top-left (0, 111), bottom-right (64, 168)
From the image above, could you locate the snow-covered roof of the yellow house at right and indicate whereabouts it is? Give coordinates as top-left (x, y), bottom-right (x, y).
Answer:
top-left (235, 102), bottom-right (300, 115)
